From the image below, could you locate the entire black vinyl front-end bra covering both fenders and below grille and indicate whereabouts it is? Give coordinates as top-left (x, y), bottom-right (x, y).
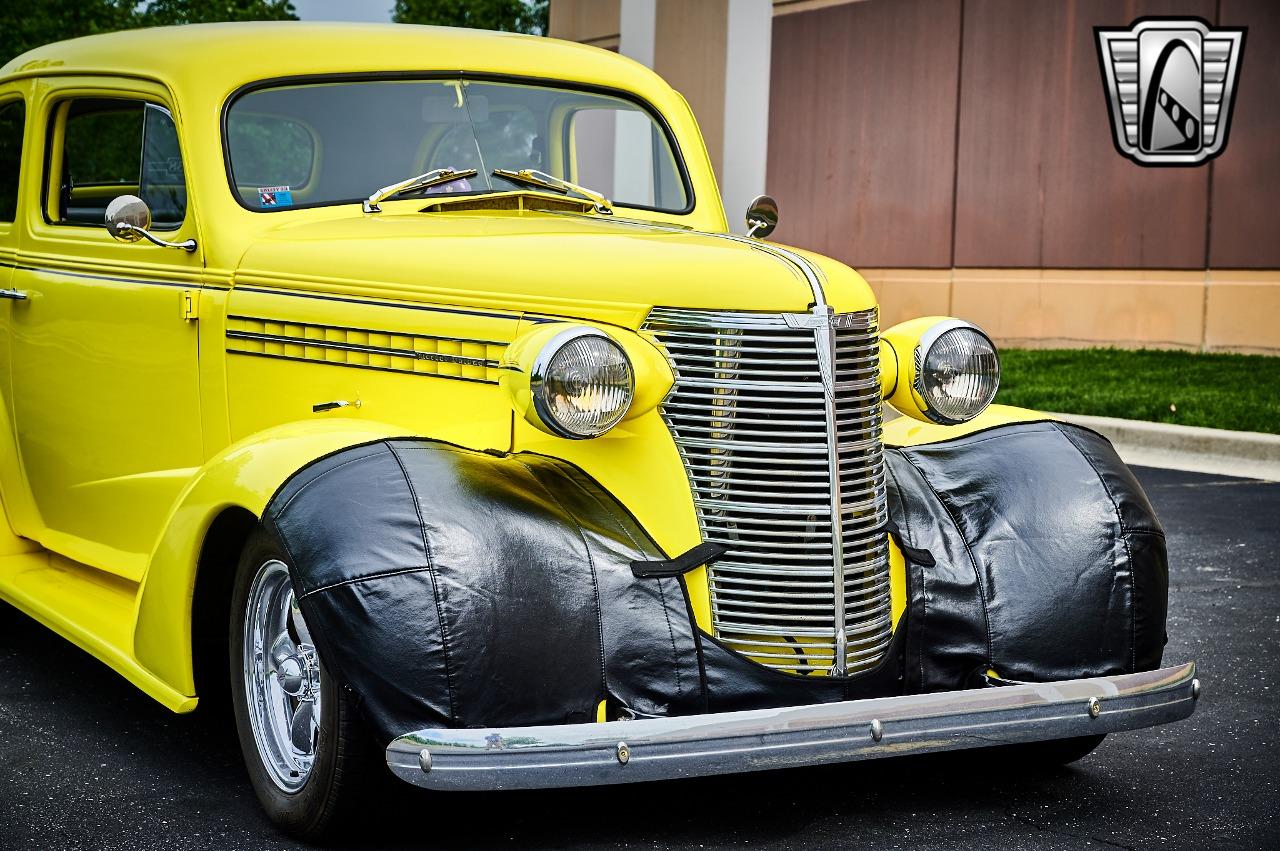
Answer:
top-left (262, 422), bottom-right (1167, 742)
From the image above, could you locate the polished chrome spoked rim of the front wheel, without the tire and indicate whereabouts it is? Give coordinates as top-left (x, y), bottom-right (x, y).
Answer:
top-left (243, 559), bottom-right (321, 793)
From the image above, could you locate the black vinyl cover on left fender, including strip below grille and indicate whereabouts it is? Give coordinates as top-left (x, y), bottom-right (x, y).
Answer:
top-left (264, 439), bottom-right (900, 742)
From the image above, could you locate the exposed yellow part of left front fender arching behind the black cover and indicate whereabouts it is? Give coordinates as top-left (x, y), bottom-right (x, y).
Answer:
top-left (133, 417), bottom-right (406, 695)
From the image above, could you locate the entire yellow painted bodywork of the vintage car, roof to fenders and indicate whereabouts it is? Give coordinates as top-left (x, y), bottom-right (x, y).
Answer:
top-left (0, 23), bottom-right (1039, 712)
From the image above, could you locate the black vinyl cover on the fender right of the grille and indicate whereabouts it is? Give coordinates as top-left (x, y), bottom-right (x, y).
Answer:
top-left (886, 421), bottom-right (1169, 691)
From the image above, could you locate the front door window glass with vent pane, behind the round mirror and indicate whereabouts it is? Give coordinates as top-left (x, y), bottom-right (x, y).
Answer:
top-left (51, 99), bottom-right (187, 230)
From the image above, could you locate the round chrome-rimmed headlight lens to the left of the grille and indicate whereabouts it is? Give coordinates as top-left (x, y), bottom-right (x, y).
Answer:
top-left (530, 328), bottom-right (635, 438)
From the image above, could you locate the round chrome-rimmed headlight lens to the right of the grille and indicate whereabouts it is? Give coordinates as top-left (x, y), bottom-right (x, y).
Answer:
top-left (915, 320), bottom-right (1000, 425)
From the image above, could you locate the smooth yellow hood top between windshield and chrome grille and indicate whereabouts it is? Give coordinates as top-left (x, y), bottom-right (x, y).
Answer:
top-left (236, 211), bottom-right (874, 328)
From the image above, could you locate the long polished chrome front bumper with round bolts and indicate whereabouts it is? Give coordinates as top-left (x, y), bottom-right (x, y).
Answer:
top-left (387, 662), bottom-right (1199, 790)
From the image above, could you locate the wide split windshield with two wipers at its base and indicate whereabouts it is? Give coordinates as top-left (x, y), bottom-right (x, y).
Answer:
top-left (227, 79), bottom-right (690, 212)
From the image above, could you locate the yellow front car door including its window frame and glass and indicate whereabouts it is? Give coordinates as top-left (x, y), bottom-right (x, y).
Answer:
top-left (10, 78), bottom-right (202, 580)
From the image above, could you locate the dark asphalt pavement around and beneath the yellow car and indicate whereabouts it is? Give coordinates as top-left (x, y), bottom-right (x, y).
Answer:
top-left (0, 468), bottom-right (1280, 851)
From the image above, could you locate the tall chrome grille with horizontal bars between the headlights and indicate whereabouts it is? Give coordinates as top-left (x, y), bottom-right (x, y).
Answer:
top-left (644, 307), bottom-right (892, 674)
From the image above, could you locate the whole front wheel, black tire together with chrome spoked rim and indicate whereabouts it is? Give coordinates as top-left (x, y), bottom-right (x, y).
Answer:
top-left (229, 527), bottom-right (376, 839)
